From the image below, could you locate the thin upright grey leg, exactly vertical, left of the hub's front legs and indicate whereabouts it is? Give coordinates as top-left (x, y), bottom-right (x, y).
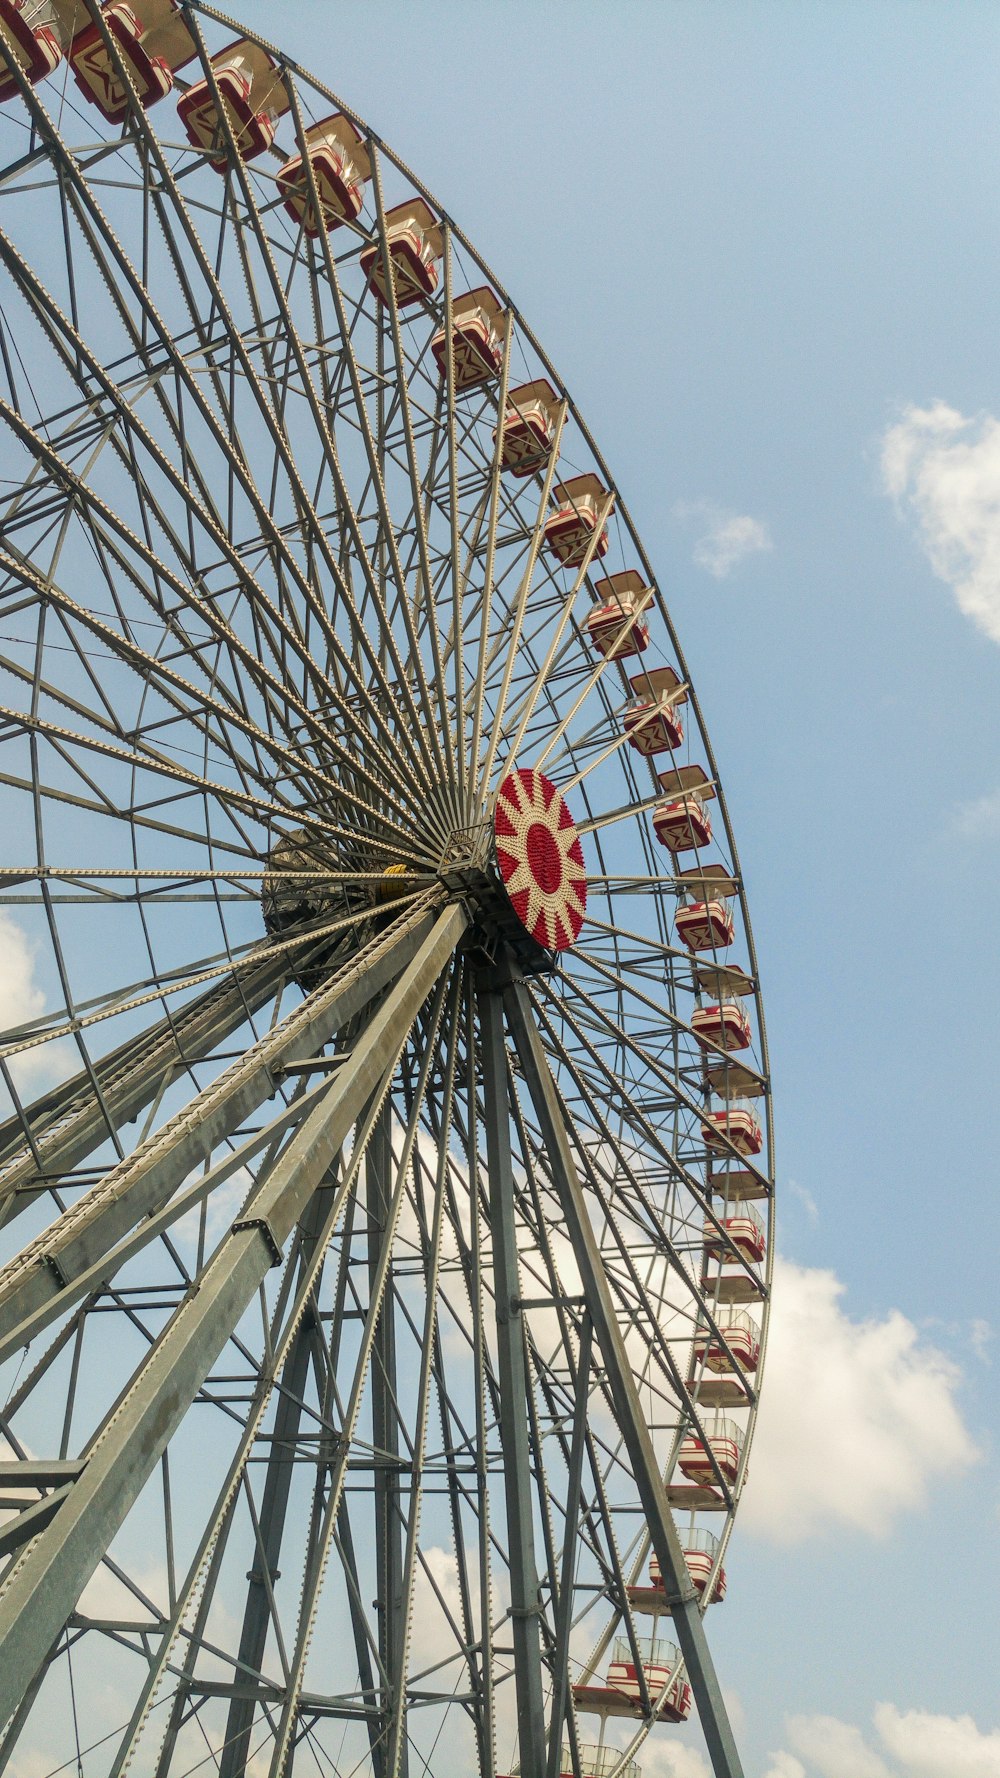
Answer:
top-left (365, 1108), bottom-right (407, 1778)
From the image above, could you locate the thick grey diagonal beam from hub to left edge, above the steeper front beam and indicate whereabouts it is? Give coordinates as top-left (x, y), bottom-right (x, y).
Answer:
top-left (0, 903), bottom-right (432, 1362)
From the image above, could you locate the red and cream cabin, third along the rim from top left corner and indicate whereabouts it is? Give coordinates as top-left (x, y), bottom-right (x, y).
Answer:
top-left (178, 37), bottom-right (288, 172)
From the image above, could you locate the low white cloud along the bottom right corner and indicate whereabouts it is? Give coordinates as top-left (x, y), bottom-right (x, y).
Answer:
top-left (765, 1703), bottom-right (1000, 1778)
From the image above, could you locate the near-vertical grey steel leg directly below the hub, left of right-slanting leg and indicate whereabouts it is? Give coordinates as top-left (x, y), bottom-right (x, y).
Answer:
top-left (479, 990), bottom-right (544, 1778)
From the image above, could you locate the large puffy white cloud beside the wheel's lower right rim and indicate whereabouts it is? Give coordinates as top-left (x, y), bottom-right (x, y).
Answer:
top-left (740, 1261), bottom-right (979, 1543)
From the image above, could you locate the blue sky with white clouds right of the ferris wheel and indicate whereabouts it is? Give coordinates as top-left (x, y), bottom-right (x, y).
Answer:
top-left (217, 0), bottom-right (1000, 1778)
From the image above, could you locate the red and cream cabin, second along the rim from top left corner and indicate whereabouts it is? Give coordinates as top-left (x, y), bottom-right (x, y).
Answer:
top-left (69, 0), bottom-right (198, 123)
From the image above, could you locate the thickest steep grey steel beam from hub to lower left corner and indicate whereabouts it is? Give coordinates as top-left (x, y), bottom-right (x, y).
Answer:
top-left (0, 903), bottom-right (468, 1721)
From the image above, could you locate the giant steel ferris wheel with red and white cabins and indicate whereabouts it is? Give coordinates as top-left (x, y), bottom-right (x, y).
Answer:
top-left (0, 10), bottom-right (774, 1778)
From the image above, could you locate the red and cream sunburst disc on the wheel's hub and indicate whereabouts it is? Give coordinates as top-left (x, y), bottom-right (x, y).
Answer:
top-left (493, 766), bottom-right (587, 951)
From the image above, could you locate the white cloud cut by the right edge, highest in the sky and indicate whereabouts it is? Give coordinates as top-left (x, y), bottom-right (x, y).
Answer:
top-left (881, 402), bottom-right (1000, 642)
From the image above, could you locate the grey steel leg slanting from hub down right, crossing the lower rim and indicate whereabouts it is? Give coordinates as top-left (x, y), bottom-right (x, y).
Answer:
top-left (504, 981), bottom-right (744, 1778)
